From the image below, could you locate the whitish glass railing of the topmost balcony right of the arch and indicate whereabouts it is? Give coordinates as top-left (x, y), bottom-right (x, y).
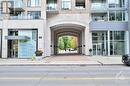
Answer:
top-left (91, 3), bottom-right (107, 10)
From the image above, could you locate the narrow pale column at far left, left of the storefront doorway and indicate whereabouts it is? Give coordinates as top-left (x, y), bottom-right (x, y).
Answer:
top-left (2, 20), bottom-right (8, 58)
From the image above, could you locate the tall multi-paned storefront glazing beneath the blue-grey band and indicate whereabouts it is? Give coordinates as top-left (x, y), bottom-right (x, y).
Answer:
top-left (92, 31), bottom-right (125, 55)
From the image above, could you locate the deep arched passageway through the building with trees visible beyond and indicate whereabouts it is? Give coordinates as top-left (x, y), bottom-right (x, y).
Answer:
top-left (51, 24), bottom-right (85, 55)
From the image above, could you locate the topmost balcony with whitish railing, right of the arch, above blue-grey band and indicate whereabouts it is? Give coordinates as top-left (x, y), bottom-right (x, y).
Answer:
top-left (91, 3), bottom-right (107, 12)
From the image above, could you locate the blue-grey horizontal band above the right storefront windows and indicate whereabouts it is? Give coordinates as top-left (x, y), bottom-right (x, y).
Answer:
top-left (90, 21), bottom-right (128, 31)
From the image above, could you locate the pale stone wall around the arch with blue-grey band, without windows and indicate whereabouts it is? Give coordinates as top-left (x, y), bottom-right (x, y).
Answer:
top-left (0, 0), bottom-right (130, 58)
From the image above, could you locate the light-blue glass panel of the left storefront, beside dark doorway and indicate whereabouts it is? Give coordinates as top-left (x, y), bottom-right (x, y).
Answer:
top-left (18, 30), bottom-right (37, 58)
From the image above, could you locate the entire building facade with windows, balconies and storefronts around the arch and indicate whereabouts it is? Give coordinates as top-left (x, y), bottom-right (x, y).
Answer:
top-left (0, 0), bottom-right (130, 58)
